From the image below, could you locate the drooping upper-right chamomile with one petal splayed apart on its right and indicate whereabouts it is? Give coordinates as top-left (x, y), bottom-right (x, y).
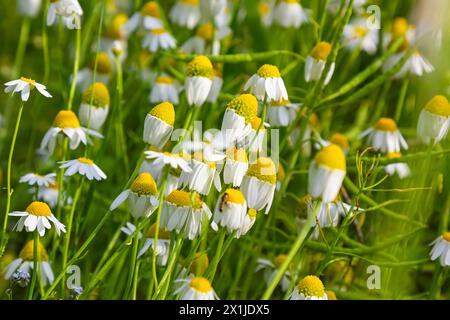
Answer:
top-left (305, 42), bottom-right (336, 85)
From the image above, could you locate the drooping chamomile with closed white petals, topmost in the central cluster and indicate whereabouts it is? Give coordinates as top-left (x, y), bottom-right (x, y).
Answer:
top-left (184, 56), bottom-right (214, 107)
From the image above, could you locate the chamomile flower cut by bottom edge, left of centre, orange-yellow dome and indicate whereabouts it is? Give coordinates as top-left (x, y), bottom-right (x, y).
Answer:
top-left (173, 276), bottom-right (219, 300)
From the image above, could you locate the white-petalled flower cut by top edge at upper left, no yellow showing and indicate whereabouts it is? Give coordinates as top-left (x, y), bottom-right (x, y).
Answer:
top-left (47, 0), bottom-right (83, 29)
